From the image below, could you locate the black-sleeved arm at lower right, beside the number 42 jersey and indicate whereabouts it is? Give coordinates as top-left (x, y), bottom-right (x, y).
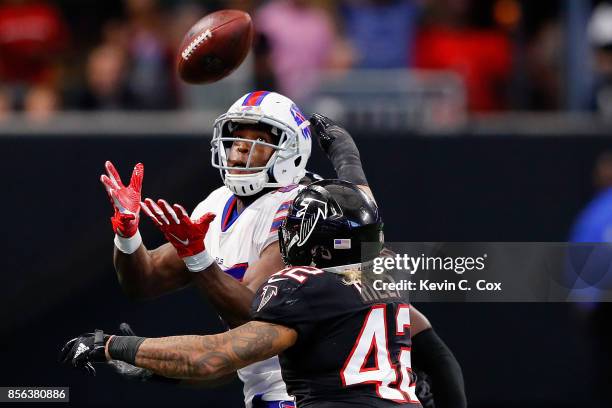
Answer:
top-left (412, 329), bottom-right (467, 408)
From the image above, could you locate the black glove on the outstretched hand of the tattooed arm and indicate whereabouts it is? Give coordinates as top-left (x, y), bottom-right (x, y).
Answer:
top-left (59, 330), bottom-right (110, 375)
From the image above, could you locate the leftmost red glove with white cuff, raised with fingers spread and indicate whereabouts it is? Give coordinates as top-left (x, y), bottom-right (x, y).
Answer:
top-left (100, 161), bottom-right (144, 254)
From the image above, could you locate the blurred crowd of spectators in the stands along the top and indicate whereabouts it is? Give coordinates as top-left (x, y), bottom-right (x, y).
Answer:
top-left (0, 0), bottom-right (612, 119)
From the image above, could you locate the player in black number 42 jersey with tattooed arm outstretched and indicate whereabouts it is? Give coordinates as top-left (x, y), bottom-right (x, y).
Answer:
top-left (63, 180), bottom-right (462, 407)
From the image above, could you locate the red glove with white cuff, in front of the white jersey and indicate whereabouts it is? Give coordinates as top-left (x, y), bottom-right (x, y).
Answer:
top-left (140, 198), bottom-right (215, 272)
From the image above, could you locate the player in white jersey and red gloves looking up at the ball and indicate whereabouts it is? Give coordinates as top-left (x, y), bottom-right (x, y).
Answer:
top-left (101, 91), bottom-right (312, 407)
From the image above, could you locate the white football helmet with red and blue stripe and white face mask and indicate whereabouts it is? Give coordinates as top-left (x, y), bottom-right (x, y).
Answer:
top-left (211, 91), bottom-right (312, 196)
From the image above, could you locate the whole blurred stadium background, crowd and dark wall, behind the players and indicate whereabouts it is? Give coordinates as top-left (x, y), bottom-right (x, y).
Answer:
top-left (0, 0), bottom-right (612, 408)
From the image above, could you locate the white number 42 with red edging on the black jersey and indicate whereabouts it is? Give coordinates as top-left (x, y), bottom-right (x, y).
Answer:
top-left (340, 305), bottom-right (418, 402)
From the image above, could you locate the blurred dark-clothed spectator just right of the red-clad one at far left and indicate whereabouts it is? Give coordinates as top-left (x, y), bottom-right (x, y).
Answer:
top-left (74, 44), bottom-right (139, 110)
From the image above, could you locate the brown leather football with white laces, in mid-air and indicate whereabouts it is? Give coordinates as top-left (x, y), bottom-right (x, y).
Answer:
top-left (177, 10), bottom-right (253, 84)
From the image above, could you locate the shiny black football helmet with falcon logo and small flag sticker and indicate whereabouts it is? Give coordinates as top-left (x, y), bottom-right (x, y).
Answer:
top-left (278, 180), bottom-right (383, 268)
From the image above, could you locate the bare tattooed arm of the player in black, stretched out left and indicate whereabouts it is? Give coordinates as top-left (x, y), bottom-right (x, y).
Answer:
top-left (126, 321), bottom-right (297, 379)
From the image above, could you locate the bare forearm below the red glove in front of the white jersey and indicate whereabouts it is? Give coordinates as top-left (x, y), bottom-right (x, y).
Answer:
top-left (194, 263), bottom-right (255, 327)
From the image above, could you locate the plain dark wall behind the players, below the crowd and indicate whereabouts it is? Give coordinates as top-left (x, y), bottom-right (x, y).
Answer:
top-left (0, 133), bottom-right (612, 407)
